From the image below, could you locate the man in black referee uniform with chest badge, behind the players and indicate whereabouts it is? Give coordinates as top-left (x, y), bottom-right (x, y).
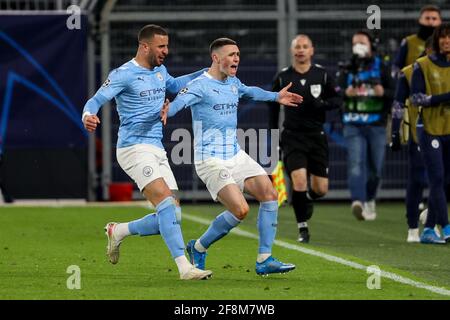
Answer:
top-left (270, 34), bottom-right (342, 243)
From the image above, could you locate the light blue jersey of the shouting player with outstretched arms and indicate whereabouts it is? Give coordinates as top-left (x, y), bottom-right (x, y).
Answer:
top-left (168, 72), bottom-right (278, 161)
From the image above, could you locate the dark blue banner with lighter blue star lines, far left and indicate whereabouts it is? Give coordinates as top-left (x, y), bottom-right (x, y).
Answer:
top-left (0, 15), bottom-right (87, 198)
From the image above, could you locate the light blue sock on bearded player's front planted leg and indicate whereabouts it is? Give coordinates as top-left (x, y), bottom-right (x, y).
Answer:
top-left (156, 197), bottom-right (184, 259)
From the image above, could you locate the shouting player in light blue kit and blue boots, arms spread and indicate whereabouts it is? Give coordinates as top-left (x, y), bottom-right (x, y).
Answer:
top-left (161, 38), bottom-right (302, 275)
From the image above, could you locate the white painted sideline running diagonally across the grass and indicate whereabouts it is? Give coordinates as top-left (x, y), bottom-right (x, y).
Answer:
top-left (183, 212), bottom-right (450, 296)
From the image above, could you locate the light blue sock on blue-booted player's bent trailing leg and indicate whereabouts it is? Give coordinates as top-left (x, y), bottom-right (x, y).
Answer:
top-left (199, 211), bottom-right (241, 249)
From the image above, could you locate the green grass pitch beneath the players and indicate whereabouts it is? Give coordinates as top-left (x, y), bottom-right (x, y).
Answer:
top-left (0, 202), bottom-right (450, 300)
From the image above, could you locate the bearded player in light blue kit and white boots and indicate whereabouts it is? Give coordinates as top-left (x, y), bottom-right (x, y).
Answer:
top-left (82, 25), bottom-right (212, 280)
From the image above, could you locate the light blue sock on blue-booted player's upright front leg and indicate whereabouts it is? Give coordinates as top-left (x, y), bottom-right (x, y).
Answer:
top-left (257, 201), bottom-right (278, 253)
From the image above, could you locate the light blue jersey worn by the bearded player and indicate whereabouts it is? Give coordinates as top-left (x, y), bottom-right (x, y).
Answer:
top-left (83, 59), bottom-right (203, 149)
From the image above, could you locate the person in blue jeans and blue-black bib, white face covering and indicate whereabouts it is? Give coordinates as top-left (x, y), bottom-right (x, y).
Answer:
top-left (337, 31), bottom-right (393, 220)
